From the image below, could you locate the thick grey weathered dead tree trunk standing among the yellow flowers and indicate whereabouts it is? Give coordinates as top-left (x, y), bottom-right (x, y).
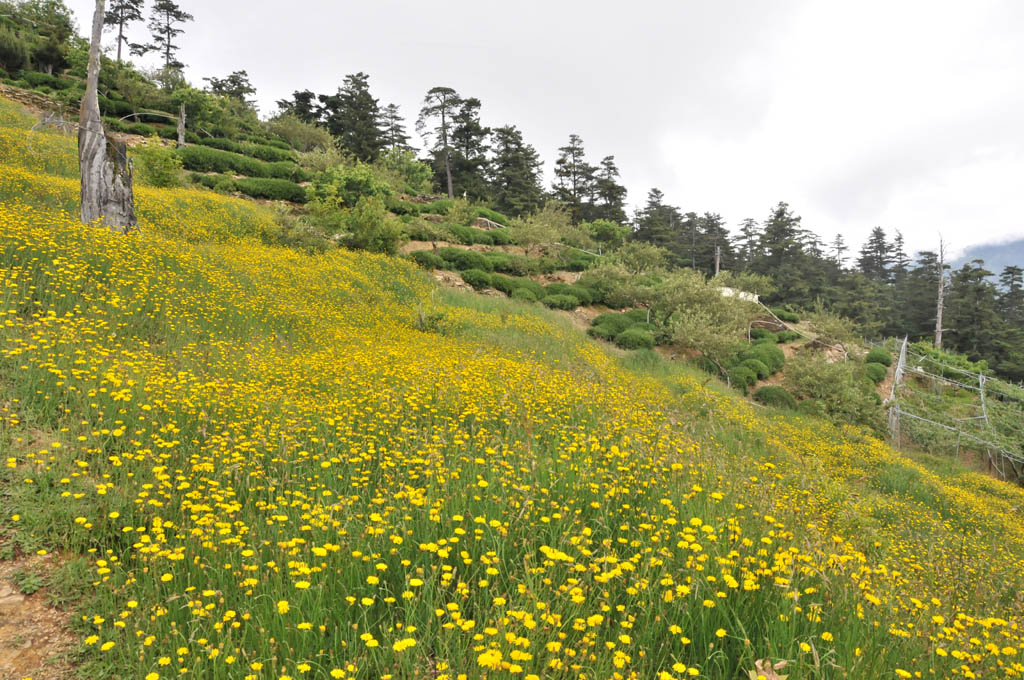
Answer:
top-left (78, 0), bottom-right (136, 233)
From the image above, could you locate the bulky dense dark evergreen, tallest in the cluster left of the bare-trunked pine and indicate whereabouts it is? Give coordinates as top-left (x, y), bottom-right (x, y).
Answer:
top-left (319, 73), bottom-right (386, 163)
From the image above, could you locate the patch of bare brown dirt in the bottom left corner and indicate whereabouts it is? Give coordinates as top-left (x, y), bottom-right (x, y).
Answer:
top-left (0, 555), bottom-right (78, 680)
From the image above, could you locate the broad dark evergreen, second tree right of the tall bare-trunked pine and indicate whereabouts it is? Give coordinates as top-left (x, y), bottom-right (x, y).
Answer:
top-left (489, 125), bottom-right (544, 216)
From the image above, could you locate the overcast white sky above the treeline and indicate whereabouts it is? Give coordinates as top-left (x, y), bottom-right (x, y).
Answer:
top-left (68, 0), bottom-right (1024, 259)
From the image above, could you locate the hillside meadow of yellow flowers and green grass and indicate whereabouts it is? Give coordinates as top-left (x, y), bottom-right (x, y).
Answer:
top-left (0, 96), bottom-right (1024, 680)
